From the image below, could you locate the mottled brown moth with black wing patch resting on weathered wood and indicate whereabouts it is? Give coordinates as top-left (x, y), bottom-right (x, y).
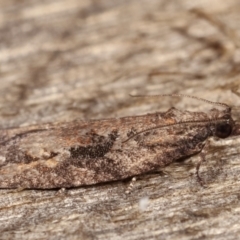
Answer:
top-left (0, 94), bottom-right (235, 189)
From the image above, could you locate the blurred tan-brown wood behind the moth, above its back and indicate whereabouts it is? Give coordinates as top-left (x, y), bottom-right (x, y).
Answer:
top-left (0, 0), bottom-right (240, 127)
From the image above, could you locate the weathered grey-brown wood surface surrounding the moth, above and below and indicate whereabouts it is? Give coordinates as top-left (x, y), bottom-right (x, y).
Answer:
top-left (0, 0), bottom-right (240, 240)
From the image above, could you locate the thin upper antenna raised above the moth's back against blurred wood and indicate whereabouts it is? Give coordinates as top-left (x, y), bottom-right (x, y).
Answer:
top-left (130, 93), bottom-right (231, 112)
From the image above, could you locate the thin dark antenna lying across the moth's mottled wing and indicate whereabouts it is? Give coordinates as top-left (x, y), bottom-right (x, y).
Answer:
top-left (122, 118), bottom-right (228, 143)
